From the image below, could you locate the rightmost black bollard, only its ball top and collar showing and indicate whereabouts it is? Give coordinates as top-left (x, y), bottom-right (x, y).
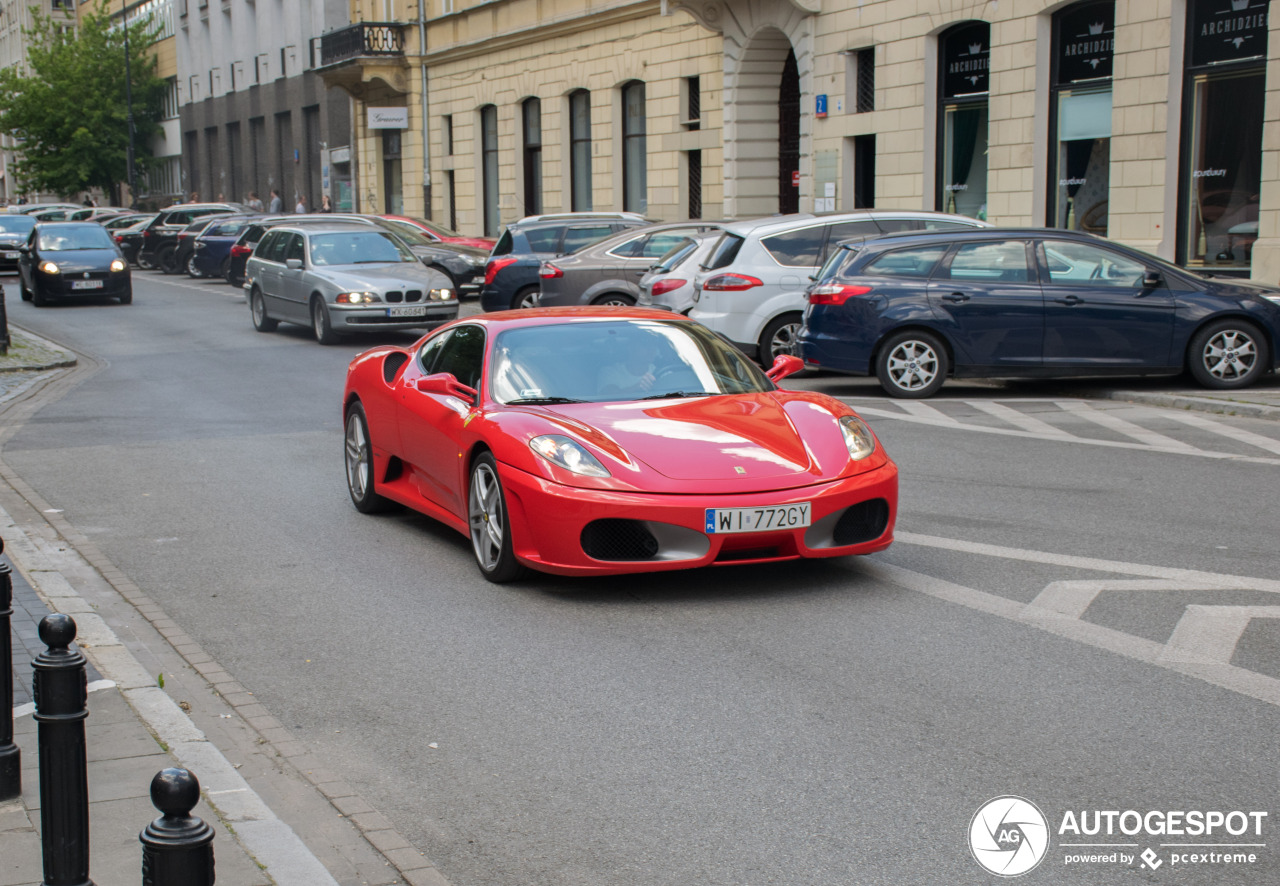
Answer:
top-left (138, 768), bottom-right (214, 886)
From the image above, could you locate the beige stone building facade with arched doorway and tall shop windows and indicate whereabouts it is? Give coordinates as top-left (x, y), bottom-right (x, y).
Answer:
top-left (321, 0), bottom-right (1280, 283)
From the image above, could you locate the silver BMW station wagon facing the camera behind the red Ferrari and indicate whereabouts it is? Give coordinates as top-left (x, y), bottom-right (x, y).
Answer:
top-left (244, 223), bottom-right (458, 344)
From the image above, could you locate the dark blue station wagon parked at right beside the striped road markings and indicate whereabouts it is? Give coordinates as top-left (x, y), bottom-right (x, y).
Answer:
top-left (800, 228), bottom-right (1280, 398)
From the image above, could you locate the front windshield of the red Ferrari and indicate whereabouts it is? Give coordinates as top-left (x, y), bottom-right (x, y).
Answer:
top-left (490, 320), bottom-right (774, 405)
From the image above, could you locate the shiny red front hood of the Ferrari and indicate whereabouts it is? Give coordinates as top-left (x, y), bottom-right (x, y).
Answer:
top-left (554, 393), bottom-right (824, 483)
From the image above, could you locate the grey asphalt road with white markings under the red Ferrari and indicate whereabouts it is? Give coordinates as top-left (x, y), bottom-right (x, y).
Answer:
top-left (0, 273), bottom-right (1280, 886)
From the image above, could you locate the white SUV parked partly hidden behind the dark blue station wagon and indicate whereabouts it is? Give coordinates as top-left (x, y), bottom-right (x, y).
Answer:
top-left (689, 209), bottom-right (988, 367)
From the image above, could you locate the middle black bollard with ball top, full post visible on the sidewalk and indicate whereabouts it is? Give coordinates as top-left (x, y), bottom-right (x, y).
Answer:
top-left (31, 613), bottom-right (93, 886)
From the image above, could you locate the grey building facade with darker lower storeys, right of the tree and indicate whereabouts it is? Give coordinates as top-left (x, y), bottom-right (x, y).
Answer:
top-left (175, 0), bottom-right (352, 211)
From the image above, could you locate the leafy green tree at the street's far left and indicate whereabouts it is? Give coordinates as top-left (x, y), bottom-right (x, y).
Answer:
top-left (0, 0), bottom-right (168, 203)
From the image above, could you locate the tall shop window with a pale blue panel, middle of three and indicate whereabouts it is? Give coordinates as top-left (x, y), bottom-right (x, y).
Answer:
top-left (1048, 0), bottom-right (1115, 237)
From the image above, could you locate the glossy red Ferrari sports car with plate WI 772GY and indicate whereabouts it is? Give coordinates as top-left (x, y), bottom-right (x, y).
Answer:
top-left (343, 307), bottom-right (897, 581)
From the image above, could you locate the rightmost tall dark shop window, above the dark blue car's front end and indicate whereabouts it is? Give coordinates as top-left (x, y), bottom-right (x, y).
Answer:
top-left (1178, 0), bottom-right (1268, 271)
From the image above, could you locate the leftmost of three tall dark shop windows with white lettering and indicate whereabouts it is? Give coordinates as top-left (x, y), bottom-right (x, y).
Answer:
top-left (936, 22), bottom-right (991, 219)
